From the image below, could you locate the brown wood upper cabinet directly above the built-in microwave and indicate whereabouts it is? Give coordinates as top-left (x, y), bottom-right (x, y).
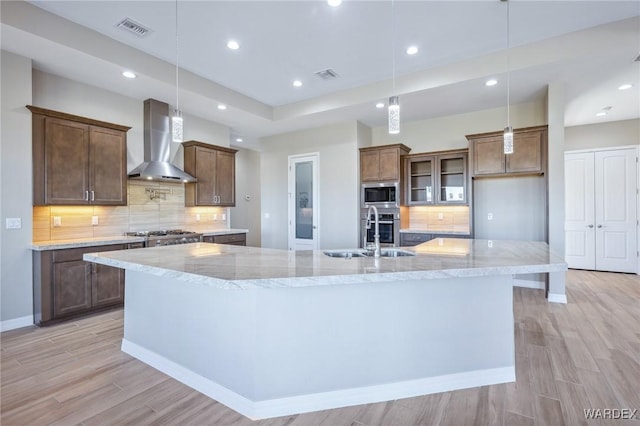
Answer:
top-left (360, 144), bottom-right (411, 182)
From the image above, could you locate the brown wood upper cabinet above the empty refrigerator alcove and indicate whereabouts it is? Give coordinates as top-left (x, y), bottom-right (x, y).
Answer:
top-left (467, 126), bottom-right (547, 177)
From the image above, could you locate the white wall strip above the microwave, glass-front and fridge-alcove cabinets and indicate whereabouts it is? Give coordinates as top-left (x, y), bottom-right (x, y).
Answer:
top-left (373, 102), bottom-right (546, 154)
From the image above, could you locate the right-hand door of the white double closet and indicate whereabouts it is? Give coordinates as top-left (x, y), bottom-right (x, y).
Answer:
top-left (595, 149), bottom-right (637, 272)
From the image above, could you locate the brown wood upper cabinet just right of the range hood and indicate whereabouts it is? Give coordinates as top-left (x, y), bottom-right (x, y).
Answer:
top-left (182, 141), bottom-right (238, 207)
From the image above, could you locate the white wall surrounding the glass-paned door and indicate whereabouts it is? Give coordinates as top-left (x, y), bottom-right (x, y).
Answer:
top-left (260, 122), bottom-right (360, 249)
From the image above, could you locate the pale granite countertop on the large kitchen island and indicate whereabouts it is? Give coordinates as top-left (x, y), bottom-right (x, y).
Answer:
top-left (84, 238), bottom-right (567, 289)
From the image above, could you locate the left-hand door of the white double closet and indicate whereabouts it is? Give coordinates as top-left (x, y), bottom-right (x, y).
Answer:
top-left (564, 152), bottom-right (596, 269)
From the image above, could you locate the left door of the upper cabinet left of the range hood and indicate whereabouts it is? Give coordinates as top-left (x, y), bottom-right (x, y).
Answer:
top-left (44, 118), bottom-right (89, 204)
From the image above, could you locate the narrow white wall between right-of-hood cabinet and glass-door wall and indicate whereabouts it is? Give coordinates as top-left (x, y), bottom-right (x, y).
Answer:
top-left (231, 149), bottom-right (261, 247)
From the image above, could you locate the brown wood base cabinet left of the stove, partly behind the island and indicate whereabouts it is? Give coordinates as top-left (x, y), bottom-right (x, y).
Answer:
top-left (33, 244), bottom-right (126, 325)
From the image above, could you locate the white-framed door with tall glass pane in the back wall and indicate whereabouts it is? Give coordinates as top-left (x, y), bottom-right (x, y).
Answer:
top-left (288, 153), bottom-right (320, 250)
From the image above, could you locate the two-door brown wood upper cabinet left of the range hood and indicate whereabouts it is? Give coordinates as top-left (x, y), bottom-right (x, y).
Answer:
top-left (27, 105), bottom-right (130, 205)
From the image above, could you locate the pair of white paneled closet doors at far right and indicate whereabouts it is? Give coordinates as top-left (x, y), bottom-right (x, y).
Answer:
top-left (565, 148), bottom-right (638, 272)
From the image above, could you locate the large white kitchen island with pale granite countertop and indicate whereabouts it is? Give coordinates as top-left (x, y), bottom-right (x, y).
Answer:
top-left (84, 239), bottom-right (567, 419)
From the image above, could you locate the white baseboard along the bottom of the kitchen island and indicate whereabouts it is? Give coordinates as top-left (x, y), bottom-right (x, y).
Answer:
top-left (122, 339), bottom-right (516, 420)
